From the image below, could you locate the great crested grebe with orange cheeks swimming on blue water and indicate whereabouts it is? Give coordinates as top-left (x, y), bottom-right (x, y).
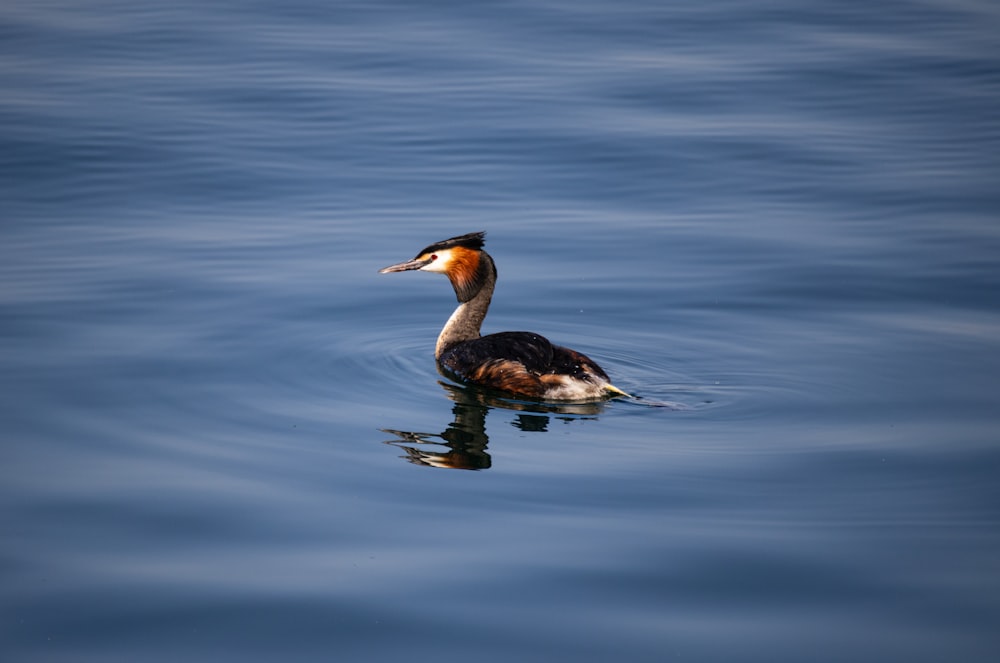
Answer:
top-left (379, 232), bottom-right (629, 401)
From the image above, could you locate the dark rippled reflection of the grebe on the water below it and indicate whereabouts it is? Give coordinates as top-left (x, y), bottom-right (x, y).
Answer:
top-left (381, 382), bottom-right (604, 470)
